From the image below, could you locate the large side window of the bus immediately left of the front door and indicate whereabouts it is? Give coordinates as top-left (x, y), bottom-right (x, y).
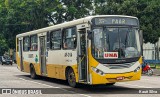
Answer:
top-left (63, 27), bottom-right (77, 49)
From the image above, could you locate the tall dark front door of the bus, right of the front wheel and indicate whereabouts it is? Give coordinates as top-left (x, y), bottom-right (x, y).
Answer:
top-left (77, 28), bottom-right (88, 82)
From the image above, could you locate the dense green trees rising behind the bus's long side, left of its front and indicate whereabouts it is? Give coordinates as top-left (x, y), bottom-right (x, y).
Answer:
top-left (0, 0), bottom-right (92, 48)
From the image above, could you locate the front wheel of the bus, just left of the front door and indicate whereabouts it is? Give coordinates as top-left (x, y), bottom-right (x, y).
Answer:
top-left (67, 69), bottom-right (76, 87)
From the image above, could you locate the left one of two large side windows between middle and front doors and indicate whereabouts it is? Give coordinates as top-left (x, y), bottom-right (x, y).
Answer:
top-left (50, 30), bottom-right (61, 50)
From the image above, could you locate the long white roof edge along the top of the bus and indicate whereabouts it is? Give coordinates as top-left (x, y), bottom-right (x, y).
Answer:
top-left (16, 15), bottom-right (138, 38)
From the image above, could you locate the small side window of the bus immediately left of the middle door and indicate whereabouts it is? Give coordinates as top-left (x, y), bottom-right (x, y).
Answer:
top-left (30, 35), bottom-right (38, 51)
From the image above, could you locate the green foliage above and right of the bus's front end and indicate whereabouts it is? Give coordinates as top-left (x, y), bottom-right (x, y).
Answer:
top-left (95, 0), bottom-right (160, 43)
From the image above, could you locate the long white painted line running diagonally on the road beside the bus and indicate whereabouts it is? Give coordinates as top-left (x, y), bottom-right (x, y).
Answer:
top-left (19, 78), bottom-right (91, 97)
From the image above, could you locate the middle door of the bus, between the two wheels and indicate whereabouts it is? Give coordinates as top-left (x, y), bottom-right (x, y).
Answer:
top-left (39, 36), bottom-right (47, 76)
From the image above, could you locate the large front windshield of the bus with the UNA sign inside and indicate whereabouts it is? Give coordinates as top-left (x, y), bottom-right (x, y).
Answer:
top-left (92, 27), bottom-right (141, 59)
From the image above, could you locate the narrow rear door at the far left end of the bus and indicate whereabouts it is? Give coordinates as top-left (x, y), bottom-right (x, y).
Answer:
top-left (19, 39), bottom-right (24, 71)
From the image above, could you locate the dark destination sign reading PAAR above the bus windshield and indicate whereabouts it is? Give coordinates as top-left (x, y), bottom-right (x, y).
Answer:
top-left (92, 17), bottom-right (138, 26)
